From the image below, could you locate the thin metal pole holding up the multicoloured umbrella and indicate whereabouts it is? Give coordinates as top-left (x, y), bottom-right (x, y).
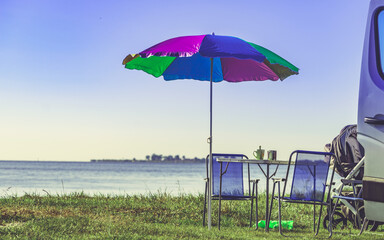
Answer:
top-left (208, 58), bottom-right (213, 230)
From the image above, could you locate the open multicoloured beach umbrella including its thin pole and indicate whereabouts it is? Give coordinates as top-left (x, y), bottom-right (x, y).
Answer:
top-left (123, 34), bottom-right (299, 228)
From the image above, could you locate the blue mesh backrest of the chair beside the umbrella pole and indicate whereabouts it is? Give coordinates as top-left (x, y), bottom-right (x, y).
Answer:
top-left (208, 153), bottom-right (250, 197)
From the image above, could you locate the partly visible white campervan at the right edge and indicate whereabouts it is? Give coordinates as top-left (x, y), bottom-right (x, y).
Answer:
top-left (357, 0), bottom-right (384, 222)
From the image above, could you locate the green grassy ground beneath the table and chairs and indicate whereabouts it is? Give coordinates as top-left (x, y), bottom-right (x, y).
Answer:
top-left (0, 192), bottom-right (384, 239)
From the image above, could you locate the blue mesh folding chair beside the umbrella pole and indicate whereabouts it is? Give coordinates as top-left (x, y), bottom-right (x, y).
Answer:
top-left (203, 153), bottom-right (259, 229)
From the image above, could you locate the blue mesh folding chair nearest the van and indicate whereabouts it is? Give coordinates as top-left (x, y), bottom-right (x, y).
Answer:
top-left (269, 150), bottom-right (335, 235)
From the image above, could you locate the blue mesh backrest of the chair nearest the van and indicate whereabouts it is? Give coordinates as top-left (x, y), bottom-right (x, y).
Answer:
top-left (283, 151), bottom-right (334, 202)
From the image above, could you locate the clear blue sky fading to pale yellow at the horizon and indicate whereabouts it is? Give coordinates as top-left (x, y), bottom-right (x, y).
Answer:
top-left (0, 0), bottom-right (369, 161)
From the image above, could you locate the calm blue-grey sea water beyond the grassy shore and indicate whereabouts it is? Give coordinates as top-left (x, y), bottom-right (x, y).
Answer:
top-left (0, 161), bottom-right (340, 197)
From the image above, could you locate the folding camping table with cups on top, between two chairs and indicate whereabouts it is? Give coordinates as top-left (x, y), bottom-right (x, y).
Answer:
top-left (217, 158), bottom-right (288, 232)
